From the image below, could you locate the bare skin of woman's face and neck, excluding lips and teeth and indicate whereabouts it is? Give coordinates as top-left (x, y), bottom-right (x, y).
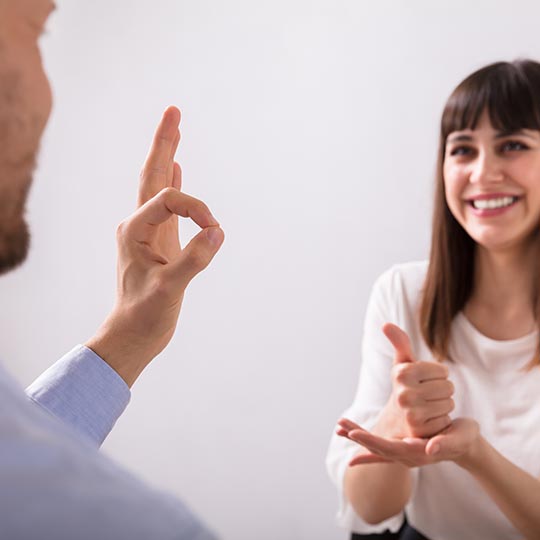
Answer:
top-left (443, 113), bottom-right (540, 340)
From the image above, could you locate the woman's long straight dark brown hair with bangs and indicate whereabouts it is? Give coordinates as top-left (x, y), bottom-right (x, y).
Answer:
top-left (420, 60), bottom-right (540, 367)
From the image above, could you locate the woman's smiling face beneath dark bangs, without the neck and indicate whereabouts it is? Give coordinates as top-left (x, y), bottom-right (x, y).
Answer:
top-left (443, 111), bottom-right (540, 251)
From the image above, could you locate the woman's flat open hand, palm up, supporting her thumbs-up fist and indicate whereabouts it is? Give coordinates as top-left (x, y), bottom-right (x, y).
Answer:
top-left (337, 418), bottom-right (480, 467)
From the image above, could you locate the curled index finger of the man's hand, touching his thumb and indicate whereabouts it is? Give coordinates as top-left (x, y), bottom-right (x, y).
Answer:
top-left (126, 187), bottom-right (219, 242)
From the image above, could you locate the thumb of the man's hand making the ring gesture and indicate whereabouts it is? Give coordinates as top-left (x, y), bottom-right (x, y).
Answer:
top-left (164, 226), bottom-right (225, 287)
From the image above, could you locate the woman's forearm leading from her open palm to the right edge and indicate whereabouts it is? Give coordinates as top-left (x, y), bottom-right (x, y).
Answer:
top-left (457, 437), bottom-right (540, 540)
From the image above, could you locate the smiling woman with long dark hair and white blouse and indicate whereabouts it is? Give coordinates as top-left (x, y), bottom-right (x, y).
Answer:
top-left (327, 60), bottom-right (540, 540)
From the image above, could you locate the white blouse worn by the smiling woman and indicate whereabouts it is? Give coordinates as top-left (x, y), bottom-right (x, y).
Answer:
top-left (326, 262), bottom-right (540, 540)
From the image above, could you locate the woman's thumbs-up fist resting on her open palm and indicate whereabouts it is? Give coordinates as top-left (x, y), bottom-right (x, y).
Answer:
top-left (373, 323), bottom-right (454, 439)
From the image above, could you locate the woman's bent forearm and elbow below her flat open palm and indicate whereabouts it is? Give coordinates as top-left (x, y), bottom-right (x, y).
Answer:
top-left (345, 463), bottom-right (411, 524)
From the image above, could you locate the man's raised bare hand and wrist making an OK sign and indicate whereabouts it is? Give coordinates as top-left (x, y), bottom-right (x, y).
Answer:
top-left (86, 107), bottom-right (224, 386)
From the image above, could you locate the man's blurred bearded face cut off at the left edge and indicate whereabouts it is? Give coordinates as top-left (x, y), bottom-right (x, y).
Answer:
top-left (0, 0), bottom-right (53, 273)
